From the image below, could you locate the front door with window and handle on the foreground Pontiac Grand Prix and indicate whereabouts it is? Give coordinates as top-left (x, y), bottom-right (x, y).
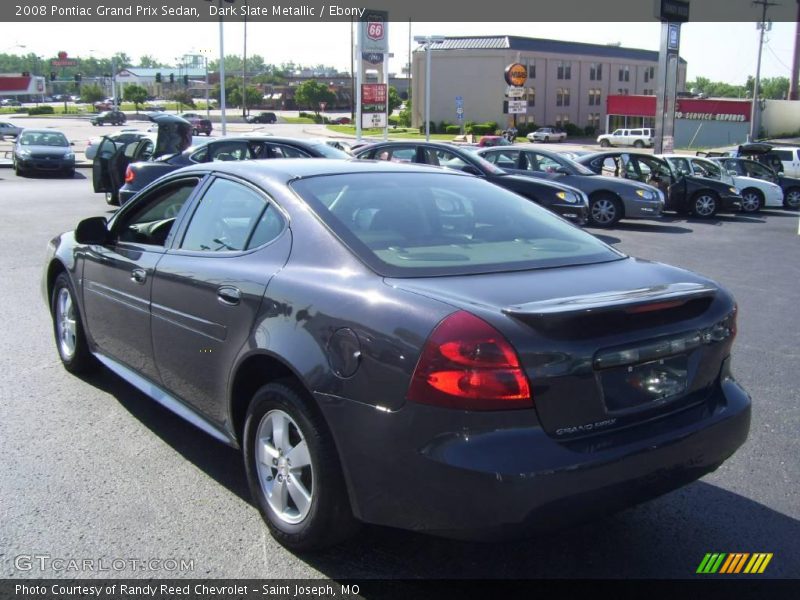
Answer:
top-left (83, 177), bottom-right (200, 381)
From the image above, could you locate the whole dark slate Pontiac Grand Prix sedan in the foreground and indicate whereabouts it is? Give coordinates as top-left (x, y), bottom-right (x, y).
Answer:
top-left (43, 159), bottom-right (750, 550)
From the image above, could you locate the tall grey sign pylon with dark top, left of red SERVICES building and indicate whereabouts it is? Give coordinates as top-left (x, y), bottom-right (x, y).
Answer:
top-left (653, 0), bottom-right (689, 154)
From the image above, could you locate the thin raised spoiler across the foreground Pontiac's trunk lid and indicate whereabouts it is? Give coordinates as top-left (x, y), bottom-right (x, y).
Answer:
top-left (503, 283), bottom-right (717, 318)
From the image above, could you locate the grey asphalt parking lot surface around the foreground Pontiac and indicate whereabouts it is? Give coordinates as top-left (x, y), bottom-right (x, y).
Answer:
top-left (0, 169), bottom-right (800, 580)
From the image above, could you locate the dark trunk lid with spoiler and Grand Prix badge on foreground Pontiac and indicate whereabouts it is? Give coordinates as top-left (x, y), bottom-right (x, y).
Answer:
top-left (387, 259), bottom-right (733, 439)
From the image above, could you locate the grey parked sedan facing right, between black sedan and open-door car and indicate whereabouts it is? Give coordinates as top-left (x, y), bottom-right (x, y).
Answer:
top-left (477, 144), bottom-right (664, 227)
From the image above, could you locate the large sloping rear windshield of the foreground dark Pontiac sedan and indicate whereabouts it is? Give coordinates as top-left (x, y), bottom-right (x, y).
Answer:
top-left (291, 173), bottom-right (624, 277)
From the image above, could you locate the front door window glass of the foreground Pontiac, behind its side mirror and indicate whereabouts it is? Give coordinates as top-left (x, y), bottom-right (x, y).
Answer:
top-left (112, 177), bottom-right (200, 247)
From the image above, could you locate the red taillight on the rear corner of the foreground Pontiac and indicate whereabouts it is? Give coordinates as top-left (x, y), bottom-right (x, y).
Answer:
top-left (408, 311), bottom-right (533, 410)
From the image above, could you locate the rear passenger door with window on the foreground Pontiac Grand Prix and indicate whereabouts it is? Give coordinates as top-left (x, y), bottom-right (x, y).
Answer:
top-left (152, 177), bottom-right (291, 425)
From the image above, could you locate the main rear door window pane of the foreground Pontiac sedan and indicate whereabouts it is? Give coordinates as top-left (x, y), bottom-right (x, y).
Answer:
top-left (181, 179), bottom-right (268, 252)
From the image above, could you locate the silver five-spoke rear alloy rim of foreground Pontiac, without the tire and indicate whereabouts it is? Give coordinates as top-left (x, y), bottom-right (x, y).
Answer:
top-left (256, 409), bottom-right (314, 525)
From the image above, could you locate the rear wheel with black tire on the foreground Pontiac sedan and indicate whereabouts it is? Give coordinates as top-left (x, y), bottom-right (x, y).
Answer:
top-left (243, 380), bottom-right (358, 551)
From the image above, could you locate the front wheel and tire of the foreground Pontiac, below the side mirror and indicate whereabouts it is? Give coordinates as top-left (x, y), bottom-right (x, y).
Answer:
top-left (50, 273), bottom-right (97, 373)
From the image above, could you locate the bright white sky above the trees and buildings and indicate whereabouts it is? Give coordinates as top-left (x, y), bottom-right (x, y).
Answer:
top-left (0, 21), bottom-right (796, 84)
